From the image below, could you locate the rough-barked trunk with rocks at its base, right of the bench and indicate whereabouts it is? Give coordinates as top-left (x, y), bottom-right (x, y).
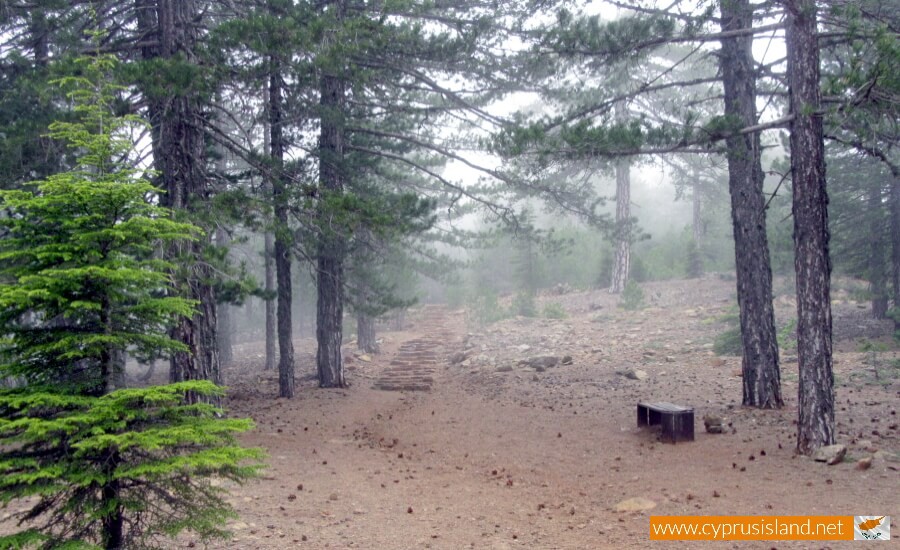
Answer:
top-left (784, 0), bottom-right (835, 454)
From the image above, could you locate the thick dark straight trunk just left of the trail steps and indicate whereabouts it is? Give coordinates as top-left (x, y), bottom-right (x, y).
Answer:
top-left (316, 63), bottom-right (346, 388)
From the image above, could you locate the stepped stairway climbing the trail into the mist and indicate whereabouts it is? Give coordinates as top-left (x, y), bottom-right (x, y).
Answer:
top-left (373, 305), bottom-right (457, 391)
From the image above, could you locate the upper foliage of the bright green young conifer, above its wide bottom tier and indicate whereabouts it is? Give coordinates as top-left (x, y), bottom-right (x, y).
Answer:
top-left (0, 52), bottom-right (197, 394)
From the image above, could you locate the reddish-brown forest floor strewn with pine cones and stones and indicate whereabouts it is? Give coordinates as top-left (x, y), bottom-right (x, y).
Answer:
top-left (204, 277), bottom-right (900, 549)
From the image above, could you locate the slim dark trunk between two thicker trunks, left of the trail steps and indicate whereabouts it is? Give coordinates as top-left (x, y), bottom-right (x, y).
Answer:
top-left (268, 56), bottom-right (294, 398)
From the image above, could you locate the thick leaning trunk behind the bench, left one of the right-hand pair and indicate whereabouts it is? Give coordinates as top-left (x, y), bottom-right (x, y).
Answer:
top-left (720, 0), bottom-right (784, 409)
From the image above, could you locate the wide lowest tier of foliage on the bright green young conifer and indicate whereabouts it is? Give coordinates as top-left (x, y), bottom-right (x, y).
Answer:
top-left (0, 381), bottom-right (262, 548)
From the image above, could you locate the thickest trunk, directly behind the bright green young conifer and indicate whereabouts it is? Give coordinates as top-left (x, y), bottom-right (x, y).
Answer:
top-left (135, 0), bottom-right (222, 383)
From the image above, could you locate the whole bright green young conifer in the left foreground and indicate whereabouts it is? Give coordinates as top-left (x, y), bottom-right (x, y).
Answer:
top-left (0, 56), bottom-right (261, 549)
